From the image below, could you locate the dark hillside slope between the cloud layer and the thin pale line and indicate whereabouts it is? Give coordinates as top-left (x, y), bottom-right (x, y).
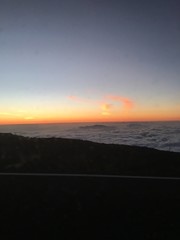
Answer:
top-left (0, 133), bottom-right (180, 177)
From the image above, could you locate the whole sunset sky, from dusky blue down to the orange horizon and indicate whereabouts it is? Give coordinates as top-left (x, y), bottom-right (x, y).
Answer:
top-left (0, 0), bottom-right (180, 124)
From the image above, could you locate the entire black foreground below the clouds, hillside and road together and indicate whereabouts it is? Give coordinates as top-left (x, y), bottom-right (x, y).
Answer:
top-left (0, 134), bottom-right (180, 240)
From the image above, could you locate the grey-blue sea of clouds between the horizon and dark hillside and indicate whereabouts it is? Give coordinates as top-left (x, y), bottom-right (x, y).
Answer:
top-left (0, 122), bottom-right (180, 152)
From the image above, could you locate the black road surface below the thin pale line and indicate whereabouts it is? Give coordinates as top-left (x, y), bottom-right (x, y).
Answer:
top-left (0, 175), bottom-right (180, 240)
